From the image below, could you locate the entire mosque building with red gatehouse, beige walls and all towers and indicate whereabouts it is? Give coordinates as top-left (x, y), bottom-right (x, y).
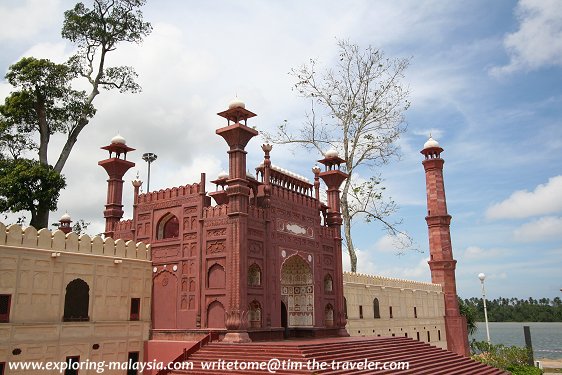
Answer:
top-left (0, 101), bottom-right (482, 374)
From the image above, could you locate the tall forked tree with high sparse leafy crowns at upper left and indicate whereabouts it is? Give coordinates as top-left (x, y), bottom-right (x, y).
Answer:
top-left (0, 0), bottom-right (152, 228)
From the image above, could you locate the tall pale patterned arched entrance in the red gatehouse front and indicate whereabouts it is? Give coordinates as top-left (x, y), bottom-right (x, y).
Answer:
top-left (281, 255), bottom-right (314, 328)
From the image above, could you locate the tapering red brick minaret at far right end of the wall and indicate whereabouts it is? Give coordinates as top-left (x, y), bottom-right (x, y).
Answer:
top-left (421, 136), bottom-right (469, 356)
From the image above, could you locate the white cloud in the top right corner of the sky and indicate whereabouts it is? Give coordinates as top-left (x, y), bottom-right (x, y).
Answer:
top-left (491, 0), bottom-right (562, 76)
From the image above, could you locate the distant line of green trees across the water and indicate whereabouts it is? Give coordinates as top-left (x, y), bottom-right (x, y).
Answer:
top-left (460, 297), bottom-right (562, 322)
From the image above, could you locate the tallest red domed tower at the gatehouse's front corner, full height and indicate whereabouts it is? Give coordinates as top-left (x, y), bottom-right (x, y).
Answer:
top-left (216, 99), bottom-right (258, 342)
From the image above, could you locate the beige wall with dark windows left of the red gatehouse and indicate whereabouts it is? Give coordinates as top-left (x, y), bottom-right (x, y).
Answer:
top-left (0, 223), bottom-right (152, 374)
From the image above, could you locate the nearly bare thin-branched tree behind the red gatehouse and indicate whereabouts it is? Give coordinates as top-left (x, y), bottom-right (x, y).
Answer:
top-left (267, 41), bottom-right (412, 272)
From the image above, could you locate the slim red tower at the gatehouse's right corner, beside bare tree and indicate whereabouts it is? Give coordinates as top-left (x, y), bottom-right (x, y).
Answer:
top-left (313, 150), bottom-right (349, 336)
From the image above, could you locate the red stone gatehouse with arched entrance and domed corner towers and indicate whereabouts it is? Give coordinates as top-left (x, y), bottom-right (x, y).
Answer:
top-left (100, 105), bottom-right (347, 342)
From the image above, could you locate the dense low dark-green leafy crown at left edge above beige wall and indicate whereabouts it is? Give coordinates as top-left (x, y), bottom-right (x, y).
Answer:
top-left (0, 158), bottom-right (66, 227)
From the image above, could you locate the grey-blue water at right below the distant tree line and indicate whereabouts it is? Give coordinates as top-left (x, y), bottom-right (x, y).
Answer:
top-left (470, 322), bottom-right (562, 360)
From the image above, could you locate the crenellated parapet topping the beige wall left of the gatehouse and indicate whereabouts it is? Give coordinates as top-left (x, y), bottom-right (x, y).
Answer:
top-left (0, 223), bottom-right (151, 260)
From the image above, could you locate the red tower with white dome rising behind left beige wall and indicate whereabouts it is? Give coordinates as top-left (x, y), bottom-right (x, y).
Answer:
top-left (98, 135), bottom-right (135, 237)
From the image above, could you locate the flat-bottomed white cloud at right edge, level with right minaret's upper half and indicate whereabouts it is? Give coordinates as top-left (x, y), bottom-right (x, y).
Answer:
top-left (486, 175), bottom-right (562, 219)
